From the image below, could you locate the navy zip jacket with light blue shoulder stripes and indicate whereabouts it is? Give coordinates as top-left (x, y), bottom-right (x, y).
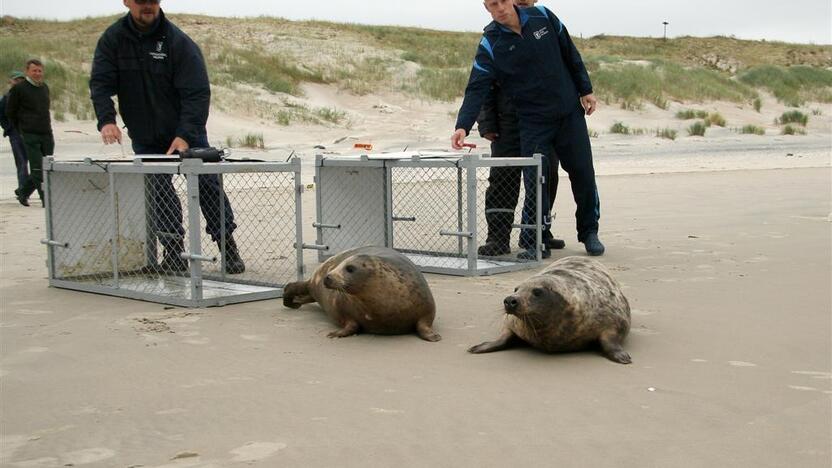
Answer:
top-left (456, 6), bottom-right (592, 132)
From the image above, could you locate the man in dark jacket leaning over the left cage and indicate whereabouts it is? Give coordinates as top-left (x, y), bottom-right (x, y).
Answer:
top-left (90, 0), bottom-right (245, 274)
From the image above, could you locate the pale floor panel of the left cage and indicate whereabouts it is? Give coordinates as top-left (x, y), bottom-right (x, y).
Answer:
top-left (68, 275), bottom-right (277, 299)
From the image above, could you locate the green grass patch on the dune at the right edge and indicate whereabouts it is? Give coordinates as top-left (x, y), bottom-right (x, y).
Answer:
top-left (739, 65), bottom-right (832, 107)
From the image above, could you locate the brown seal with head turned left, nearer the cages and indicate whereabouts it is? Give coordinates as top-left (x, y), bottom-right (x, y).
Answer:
top-left (283, 247), bottom-right (441, 341)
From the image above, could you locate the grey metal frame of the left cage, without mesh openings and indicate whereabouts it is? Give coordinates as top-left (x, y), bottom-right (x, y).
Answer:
top-left (41, 157), bottom-right (304, 307)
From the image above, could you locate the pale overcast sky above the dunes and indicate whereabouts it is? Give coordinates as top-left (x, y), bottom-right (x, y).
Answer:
top-left (0, 0), bottom-right (832, 44)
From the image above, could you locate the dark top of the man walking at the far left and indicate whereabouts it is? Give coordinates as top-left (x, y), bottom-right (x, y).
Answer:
top-left (6, 80), bottom-right (52, 135)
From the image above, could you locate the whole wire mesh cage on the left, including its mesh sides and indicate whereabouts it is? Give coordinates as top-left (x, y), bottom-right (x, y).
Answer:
top-left (43, 158), bottom-right (302, 307)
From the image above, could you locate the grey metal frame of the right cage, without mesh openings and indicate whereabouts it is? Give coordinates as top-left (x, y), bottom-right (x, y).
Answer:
top-left (312, 152), bottom-right (544, 276)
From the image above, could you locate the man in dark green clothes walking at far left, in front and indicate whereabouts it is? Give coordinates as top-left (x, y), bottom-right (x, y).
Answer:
top-left (6, 59), bottom-right (55, 206)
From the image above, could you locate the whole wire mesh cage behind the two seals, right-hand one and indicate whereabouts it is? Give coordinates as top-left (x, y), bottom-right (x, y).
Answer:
top-left (316, 153), bottom-right (541, 276)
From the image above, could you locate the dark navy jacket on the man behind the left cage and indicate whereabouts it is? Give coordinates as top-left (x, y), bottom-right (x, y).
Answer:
top-left (90, 12), bottom-right (211, 146)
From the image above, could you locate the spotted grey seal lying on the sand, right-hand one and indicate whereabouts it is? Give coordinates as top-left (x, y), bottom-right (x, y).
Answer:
top-left (468, 257), bottom-right (632, 364)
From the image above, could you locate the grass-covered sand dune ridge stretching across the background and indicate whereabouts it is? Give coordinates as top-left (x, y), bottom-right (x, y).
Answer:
top-left (0, 15), bottom-right (832, 123)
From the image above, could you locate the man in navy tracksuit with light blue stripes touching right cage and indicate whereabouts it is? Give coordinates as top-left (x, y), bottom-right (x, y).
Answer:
top-left (451, 0), bottom-right (604, 258)
